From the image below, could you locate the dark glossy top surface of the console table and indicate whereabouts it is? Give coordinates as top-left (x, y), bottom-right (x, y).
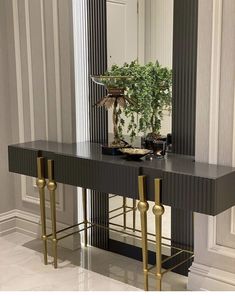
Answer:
top-left (12, 140), bottom-right (235, 179)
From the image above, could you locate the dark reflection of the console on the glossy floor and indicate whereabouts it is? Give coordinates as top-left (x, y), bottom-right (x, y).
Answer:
top-left (24, 231), bottom-right (187, 291)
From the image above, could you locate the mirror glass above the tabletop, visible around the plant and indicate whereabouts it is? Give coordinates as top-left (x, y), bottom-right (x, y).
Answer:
top-left (107, 0), bottom-right (173, 140)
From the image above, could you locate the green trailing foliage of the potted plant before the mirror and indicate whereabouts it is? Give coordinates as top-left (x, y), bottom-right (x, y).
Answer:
top-left (105, 61), bottom-right (172, 140)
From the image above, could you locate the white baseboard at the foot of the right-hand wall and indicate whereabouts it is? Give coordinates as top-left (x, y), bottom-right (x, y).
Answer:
top-left (188, 263), bottom-right (235, 291)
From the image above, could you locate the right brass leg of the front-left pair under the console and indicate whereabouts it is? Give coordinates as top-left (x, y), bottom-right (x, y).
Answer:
top-left (47, 160), bottom-right (57, 268)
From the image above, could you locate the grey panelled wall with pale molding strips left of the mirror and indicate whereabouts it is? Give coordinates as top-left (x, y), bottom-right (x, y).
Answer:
top-left (0, 0), bottom-right (77, 224)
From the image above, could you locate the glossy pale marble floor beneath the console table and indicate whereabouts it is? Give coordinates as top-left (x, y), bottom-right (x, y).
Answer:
top-left (0, 232), bottom-right (187, 291)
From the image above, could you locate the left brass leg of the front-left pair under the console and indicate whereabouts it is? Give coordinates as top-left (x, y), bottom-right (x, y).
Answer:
top-left (36, 157), bottom-right (47, 265)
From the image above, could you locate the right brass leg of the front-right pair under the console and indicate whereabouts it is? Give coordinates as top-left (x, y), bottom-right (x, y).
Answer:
top-left (153, 179), bottom-right (164, 291)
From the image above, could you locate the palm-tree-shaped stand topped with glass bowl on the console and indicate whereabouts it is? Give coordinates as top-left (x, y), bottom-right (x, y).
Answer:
top-left (91, 73), bottom-right (133, 155)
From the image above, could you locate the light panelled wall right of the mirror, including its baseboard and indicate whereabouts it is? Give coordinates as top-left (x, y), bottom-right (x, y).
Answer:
top-left (189, 0), bottom-right (235, 290)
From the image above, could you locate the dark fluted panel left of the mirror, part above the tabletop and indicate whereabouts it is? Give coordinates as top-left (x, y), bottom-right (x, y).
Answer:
top-left (87, 0), bottom-right (108, 142)
